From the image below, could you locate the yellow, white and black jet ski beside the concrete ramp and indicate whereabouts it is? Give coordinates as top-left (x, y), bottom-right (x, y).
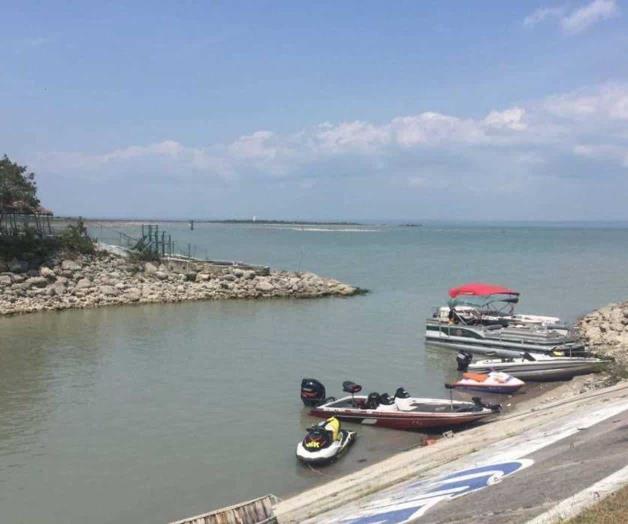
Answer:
top-left (297, 417), bottom-right (356, 465)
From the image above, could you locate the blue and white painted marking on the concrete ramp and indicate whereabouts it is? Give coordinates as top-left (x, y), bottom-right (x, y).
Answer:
top-left (339, 459), bottom-right (533, 524)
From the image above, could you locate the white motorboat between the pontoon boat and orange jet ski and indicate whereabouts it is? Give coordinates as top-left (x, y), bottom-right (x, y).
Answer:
top-left (456, 352), bottom-right (610, 382)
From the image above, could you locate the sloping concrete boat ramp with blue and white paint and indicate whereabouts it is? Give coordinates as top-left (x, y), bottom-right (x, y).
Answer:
top-left (172, 382), bottom-right (628, 524)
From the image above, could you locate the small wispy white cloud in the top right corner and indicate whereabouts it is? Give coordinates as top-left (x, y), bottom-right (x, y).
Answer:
top-left (523, 0), bottom-right (619, 34)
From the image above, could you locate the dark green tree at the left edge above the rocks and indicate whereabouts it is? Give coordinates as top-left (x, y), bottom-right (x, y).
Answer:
top-left (0, 155), bottom-right (39, 211)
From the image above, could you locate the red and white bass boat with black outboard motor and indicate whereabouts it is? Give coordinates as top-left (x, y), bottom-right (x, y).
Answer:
top-left (301, 378), bottom-right (501, 430)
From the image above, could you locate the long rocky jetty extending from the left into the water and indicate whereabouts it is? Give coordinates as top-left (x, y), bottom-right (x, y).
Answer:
top-left (0, 251), bottom-right (360, 315)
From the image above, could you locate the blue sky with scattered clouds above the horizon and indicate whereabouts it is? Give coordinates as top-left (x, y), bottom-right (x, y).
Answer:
top-left (0, 0), bottom-right (628, 221)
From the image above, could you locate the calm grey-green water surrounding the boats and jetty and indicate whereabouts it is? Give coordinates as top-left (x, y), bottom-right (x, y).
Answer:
top-left (0, 224), bottom-right (628, 523)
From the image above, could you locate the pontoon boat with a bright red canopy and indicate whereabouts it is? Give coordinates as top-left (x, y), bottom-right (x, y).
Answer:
top-left (425, 283), bottom-right (586, 357)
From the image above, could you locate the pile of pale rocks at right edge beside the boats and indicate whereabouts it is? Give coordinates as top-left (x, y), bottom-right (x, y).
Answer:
top-left (577, 302), bottom-right (628, 370)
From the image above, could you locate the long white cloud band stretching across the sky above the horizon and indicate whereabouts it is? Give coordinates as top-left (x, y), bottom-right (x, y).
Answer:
top-left (33, 84), bottom-right (628, 188)
